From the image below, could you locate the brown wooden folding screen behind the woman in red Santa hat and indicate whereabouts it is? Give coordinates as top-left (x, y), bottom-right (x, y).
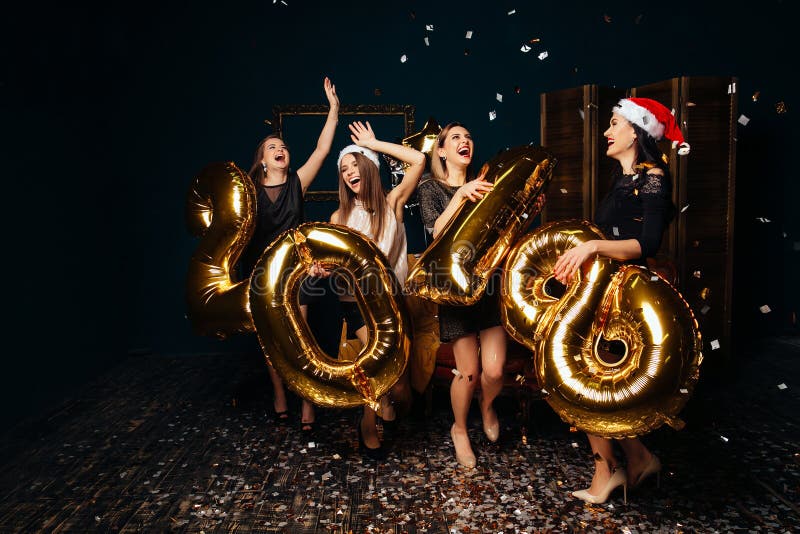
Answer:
top-left (541, 77), bottom-right (737, 363)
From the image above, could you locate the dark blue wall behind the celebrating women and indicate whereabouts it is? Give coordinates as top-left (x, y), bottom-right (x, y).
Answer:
top-left (0, 0), bottom-right (800, 428)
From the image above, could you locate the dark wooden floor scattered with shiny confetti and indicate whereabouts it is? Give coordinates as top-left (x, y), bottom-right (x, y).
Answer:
top-left (0, 337), bottom-right (800, 533)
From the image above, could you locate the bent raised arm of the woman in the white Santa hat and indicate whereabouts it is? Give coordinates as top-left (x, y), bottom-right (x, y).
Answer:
top-left (350, 121), bottom-right (425, 222)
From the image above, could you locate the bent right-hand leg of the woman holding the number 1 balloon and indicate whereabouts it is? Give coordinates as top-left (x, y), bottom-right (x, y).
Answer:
top-left (480, 326), bottom-right (506, 441)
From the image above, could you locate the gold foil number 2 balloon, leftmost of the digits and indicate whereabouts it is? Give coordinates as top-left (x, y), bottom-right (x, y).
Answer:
top-left (186, 162), bottom-right (256, 338)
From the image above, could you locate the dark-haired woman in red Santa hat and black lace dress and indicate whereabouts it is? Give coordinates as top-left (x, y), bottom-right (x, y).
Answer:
top-left (554, 98), bottom-right (689, 503)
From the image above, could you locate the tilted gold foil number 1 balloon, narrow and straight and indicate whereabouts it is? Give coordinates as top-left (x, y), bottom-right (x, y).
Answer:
top-left (406, 146), bottom-right (556, 305)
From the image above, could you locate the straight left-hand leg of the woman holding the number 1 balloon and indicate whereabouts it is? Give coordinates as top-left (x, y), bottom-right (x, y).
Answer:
top-left (450, 334), bottom-right (479, 465)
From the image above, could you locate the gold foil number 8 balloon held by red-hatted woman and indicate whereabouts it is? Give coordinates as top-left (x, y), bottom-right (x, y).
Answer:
top-left (502, 221), bottom-right (702, 438)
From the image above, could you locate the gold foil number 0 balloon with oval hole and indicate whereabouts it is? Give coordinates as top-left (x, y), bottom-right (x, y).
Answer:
top-left (250, 223), bottom-right (411, 411)
